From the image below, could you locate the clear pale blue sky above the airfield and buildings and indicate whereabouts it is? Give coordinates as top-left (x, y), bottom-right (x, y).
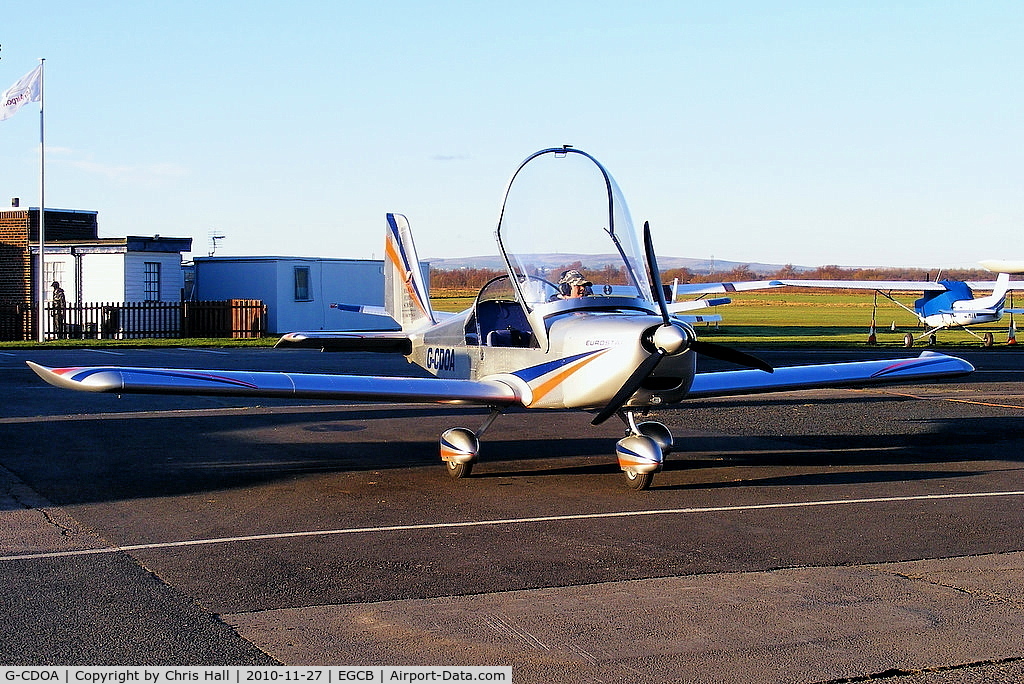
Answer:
top-left (0, 0), bottom-right (1024, 268)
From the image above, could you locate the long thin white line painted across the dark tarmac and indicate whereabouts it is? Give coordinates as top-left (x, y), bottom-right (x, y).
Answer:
top-left (0, 490), bottom-right (1024, 561)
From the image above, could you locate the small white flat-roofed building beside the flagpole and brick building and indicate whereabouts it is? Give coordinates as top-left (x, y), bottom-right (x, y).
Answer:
top-left (31, 236), bottom-right (191, 304)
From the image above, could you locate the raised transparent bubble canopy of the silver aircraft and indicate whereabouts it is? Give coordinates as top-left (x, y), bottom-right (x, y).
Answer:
top-left (497, 146), bottom-right (652, 309)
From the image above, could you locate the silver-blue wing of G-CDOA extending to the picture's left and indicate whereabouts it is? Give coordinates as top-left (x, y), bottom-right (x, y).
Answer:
top-left (28, 361), bottom-right (520, 405)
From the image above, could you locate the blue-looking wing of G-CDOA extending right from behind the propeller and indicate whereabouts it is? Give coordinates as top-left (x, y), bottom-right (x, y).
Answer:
top-left (686, 351), bottom-right (974, 398)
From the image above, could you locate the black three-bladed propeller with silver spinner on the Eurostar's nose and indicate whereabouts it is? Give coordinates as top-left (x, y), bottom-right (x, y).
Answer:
top-left (591, 221), bottom-right (774, 425)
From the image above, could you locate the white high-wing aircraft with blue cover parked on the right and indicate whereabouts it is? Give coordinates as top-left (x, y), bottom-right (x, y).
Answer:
top-left (777, 272), bottom-right (1024, 347)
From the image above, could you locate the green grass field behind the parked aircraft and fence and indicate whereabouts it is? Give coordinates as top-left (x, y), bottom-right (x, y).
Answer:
top-left (0, 290), bottom-right (1024, 348)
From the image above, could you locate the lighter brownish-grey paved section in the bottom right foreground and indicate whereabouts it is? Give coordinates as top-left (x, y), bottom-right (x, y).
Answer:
top-left (225, 553), bottom-right (1024, 684)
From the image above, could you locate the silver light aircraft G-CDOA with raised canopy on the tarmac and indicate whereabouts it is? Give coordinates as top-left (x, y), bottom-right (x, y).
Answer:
top-left (29, 146), bottom-right (974, 489)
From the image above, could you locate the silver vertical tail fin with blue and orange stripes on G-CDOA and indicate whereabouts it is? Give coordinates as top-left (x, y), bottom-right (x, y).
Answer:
top-left (384, 214), bottom-right (436, 330)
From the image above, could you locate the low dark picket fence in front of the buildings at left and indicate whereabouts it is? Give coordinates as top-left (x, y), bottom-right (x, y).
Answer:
top-left (0, 299), bottom-right (266, 340)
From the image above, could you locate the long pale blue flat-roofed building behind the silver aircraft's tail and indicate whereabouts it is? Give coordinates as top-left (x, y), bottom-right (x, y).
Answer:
top-left (190, 256), bottom-right (430, 334)
